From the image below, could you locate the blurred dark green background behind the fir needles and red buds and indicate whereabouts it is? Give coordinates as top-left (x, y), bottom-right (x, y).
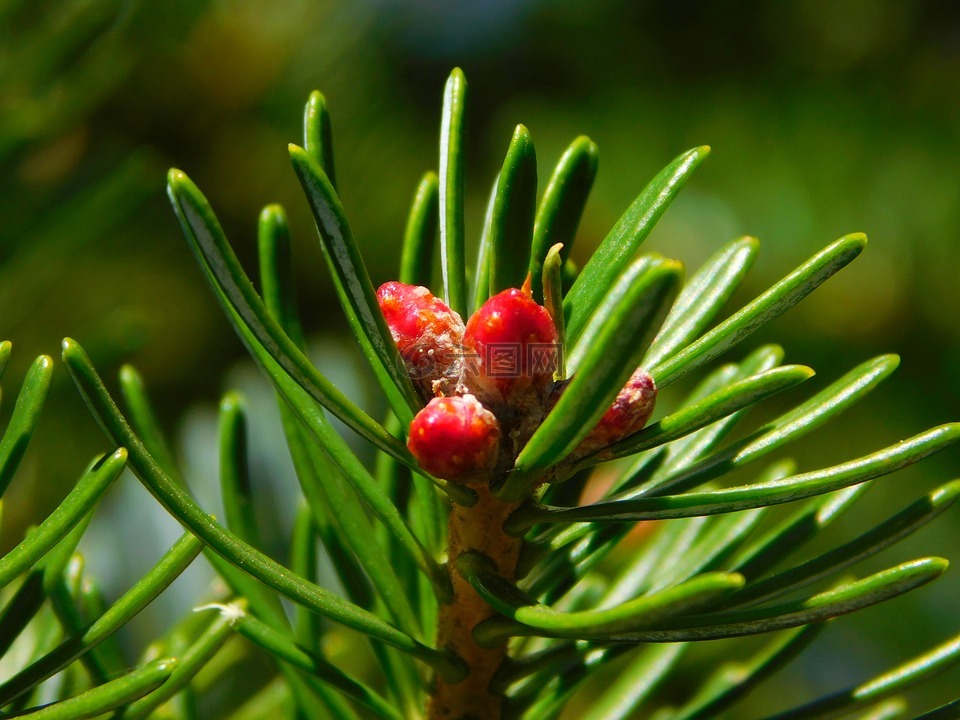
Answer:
top-left (0, 0), bottom-right (960, 717)
